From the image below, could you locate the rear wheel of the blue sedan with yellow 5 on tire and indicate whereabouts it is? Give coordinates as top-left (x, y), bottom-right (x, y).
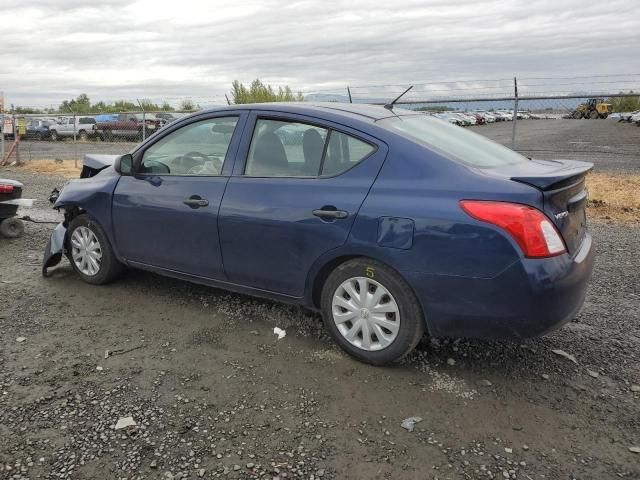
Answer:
top-left (321, 257), bottom-right (425, 365)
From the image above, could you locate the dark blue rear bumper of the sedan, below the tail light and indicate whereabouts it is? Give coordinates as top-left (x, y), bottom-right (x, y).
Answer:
top-left (405, 233), bottom-right (595, 338)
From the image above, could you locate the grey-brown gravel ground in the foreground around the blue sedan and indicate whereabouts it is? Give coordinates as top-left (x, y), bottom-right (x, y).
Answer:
top-left (0, 170), bottom-right (640, 480)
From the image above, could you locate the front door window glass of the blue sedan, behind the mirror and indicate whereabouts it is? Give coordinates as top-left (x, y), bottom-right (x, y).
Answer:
top-left (139, 117), bottom-right (238, 176)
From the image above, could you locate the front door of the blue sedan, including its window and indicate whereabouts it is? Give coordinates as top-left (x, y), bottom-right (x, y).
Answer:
top-left (113, 113), bottom-right (246, 279)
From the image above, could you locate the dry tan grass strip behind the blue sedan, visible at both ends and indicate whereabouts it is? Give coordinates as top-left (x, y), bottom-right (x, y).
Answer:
top-left (8, 160), bottom-right (640, 223)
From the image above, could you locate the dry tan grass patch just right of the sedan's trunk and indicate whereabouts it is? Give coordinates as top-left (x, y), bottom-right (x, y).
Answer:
top-left (587, 173), bottom-right (640, 223)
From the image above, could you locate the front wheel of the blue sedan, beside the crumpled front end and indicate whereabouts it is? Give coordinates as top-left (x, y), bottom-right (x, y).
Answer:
top-left (67, 214), bottom-right (124, 285)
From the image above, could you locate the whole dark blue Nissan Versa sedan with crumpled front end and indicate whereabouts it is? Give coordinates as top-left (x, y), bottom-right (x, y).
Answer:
top-left (44, 103), bottom-right (594, 364)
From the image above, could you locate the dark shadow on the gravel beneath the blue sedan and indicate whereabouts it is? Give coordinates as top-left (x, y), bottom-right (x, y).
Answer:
top-left (46, 261), bottom-right (573, 382)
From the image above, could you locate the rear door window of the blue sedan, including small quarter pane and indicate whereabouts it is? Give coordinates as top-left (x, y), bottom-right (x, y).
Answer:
top-left (245, 119), bottom-right (375, 177)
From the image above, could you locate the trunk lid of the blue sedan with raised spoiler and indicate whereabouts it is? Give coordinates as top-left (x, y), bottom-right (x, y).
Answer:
top-left (488, 160), bottom-right (593, 255)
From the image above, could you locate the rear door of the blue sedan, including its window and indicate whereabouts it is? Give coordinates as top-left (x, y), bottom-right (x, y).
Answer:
top-left (220, 112), bottom-right (387, 297)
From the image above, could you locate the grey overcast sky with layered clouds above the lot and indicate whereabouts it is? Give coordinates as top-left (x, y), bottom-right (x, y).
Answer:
top-left (0, 0), bottom-right (640, 106)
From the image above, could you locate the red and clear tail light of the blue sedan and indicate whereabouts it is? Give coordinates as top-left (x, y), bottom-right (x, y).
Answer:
top-left (460, 200), bottom-right (566, 258)
